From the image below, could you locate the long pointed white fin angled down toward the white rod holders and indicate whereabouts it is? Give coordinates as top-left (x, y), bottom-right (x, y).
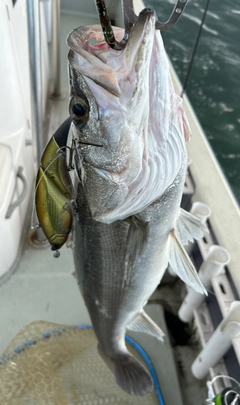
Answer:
top-left (169, 231), bottom-right (207, 295)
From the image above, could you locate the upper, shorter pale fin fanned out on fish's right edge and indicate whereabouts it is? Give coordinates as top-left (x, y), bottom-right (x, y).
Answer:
top-left (176, 208), bottom-right (208, 245)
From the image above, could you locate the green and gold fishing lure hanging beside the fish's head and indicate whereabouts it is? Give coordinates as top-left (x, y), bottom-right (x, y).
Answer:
top-left (35, 116), bottom-right (73, 250)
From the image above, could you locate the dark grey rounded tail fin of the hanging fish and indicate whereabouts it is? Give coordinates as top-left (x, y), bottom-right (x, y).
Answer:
top-left (99, 350), bottom-right (154, 395)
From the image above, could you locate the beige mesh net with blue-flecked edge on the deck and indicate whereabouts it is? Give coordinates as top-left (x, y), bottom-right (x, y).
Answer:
top-left (0, 321), bottom-right (159, 405)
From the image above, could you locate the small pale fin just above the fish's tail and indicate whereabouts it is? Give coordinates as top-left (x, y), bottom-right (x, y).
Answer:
top-left (127, 311), bottom-right (164, 341)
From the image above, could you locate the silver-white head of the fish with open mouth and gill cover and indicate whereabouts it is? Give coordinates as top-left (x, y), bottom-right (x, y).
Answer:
top-left (67, 8), bottom-right (189, 223)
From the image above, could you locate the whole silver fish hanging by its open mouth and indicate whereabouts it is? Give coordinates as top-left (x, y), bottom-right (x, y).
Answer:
top-left (68, 8), bottom-right (206, 395)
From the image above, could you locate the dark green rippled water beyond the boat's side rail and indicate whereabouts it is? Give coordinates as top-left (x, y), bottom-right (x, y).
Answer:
top-left (148, 0), bottom-right (240, 202)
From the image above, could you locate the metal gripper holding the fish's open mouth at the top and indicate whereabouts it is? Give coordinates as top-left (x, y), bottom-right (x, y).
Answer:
top-left (95, 0), bottom-right (188, 51)
